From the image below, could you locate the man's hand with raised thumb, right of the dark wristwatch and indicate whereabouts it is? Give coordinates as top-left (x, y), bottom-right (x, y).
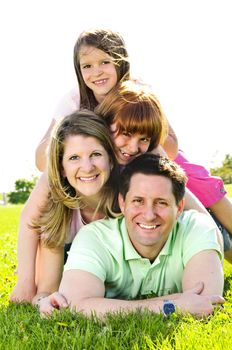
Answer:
top-left (175, 282), bottom-right (225, 317)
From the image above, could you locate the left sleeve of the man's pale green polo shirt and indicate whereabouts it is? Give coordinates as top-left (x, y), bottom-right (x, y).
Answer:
top-left (64, 225), bottom-right (111, 282)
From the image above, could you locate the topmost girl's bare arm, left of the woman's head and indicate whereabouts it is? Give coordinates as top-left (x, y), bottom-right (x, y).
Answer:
top-left (35, 119), bottom-right (56, 172)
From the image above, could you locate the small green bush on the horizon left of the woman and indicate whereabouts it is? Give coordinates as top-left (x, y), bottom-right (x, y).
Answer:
top-left (7, 177), bottom-right (36, 204)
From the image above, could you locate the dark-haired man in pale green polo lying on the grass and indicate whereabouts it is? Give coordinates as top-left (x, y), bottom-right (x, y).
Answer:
top-left (40, 154), bottom-right (224, 316)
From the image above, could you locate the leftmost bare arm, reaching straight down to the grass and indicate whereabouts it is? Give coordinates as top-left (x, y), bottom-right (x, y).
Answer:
top-left (10, 174), bottom-right (48, 302)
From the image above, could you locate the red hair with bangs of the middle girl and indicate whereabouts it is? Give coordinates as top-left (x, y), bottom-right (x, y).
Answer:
top-left (95, 80), bottom-right (168, 150)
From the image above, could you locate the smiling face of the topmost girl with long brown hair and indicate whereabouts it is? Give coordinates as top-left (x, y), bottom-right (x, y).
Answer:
top-left (79, 45), bottom-right (118, 103)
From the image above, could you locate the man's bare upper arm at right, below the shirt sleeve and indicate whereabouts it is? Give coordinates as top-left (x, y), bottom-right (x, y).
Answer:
top-left (182, 249), bottom-right (224, 295)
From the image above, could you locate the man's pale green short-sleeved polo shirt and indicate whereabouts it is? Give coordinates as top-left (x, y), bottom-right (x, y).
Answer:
top-left (64, 210), bottom-right (222, 299)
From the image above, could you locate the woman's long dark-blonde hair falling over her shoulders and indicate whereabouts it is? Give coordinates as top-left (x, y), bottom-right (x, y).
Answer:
top-left (34, 110), bottom-right (118, 248)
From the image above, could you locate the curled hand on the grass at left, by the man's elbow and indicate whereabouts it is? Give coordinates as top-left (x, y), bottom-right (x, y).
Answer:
top-left (37, 292), bottom-right (68, 316)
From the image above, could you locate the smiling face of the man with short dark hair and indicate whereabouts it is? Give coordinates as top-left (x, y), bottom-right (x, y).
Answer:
top-left (119, 173), bottom-right (183, 259)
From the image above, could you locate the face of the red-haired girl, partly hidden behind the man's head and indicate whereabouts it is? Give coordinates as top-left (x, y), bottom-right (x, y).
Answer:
top-left (110, 123), bottom-right (151, 165)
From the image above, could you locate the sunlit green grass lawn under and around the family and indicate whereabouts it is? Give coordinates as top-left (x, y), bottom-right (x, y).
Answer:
top-left (0, 206), bottom-right (232, 350)
